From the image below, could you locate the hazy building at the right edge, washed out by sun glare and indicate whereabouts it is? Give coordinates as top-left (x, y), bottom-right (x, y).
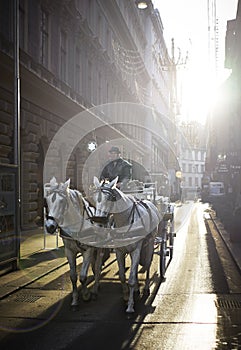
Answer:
top-left (206, 1), bottom-right (241, 206)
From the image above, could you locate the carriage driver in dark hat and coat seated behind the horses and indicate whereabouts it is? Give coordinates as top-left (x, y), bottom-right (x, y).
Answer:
top-left (100, 146), bottom-right (132, 190)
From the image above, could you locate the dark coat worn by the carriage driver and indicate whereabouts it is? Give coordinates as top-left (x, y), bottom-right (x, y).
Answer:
top-left (100, 158), bottom-right (132, 182)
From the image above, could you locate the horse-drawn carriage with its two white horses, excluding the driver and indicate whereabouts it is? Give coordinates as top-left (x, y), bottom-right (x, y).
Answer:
top-left (44, 177), bottom-right (174, 314)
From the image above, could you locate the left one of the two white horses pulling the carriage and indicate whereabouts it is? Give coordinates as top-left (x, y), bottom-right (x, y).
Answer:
top-left (45, 178), bottom-right (109, 307)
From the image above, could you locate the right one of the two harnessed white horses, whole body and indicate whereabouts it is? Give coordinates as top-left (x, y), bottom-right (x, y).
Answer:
top-left (93, 177), bottom-right (161, 315)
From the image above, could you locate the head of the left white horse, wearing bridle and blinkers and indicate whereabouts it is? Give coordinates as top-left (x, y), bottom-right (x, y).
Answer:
top-left (45, 178), bottom-right (70, 227)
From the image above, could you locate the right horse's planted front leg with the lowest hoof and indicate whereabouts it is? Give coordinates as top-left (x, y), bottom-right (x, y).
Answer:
top-left (126, 247), bottom-right (140, 314)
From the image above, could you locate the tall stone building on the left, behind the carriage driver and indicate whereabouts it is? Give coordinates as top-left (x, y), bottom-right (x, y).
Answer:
top-left (0, 0), bottom-right (172, 266)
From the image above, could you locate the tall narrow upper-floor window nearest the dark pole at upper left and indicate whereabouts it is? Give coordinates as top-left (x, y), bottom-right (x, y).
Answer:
top-left (40, 9), bottom-right (49, 67)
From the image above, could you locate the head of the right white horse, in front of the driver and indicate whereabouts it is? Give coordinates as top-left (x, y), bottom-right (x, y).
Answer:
top-left (92, 177), bottom-right (120, 223)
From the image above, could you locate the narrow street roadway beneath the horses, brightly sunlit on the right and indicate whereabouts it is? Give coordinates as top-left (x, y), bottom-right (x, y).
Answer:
top-left (0, 202), bottom-right (241, 350)
